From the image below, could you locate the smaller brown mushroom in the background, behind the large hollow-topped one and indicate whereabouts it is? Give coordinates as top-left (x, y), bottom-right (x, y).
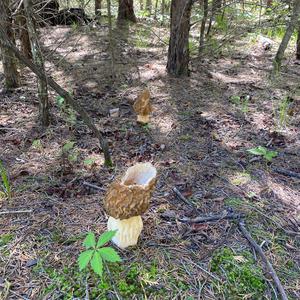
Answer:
top-left (133, 89), bottom-right (152, 124)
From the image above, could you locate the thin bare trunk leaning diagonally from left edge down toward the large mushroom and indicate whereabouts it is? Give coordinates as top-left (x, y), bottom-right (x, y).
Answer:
top-left (0, 15), bottom-right (112, 166)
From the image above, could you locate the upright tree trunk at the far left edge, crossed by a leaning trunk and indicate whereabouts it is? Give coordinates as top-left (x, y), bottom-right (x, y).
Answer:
top-left (0, 0), bottom-right (19, 91)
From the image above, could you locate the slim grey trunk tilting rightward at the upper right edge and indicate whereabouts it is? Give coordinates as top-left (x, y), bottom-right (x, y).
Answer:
top-left (273, 0), bottom-right (300, 74)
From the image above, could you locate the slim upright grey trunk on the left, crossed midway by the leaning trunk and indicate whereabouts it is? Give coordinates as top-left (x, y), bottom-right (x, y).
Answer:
top-left (24, 0), bottom-right (50, 126)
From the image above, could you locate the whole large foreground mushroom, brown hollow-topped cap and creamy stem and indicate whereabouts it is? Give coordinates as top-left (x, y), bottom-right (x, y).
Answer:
top-left (104, 163), bottom-right (157, 249)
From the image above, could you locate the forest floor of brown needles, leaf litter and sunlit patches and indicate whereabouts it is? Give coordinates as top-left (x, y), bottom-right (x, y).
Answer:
top-left (0, 19), bottom-right (300, 299)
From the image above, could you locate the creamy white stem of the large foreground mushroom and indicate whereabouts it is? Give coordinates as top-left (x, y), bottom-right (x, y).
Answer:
top-left (107, 216), bottom-right (143, 249)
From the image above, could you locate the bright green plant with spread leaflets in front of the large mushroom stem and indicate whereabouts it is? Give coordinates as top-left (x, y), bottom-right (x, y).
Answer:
top-left (78, 230), bottom-right (121, 277)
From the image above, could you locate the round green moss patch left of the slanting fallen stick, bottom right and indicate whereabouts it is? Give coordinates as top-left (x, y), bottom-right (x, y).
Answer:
top-left (211, 247), bottom-right (266, 299)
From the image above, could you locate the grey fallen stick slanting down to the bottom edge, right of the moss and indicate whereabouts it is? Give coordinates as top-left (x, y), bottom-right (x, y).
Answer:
top-left (239, 219), bottom-right (288, 300)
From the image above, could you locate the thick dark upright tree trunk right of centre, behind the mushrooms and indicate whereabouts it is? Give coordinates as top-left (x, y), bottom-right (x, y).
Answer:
top-left (167, 0), bottom-right (193, 76)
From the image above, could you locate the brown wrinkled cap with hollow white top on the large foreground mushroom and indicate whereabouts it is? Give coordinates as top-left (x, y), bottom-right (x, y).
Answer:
top-left (104, 163), bottom-right (157, 220)
